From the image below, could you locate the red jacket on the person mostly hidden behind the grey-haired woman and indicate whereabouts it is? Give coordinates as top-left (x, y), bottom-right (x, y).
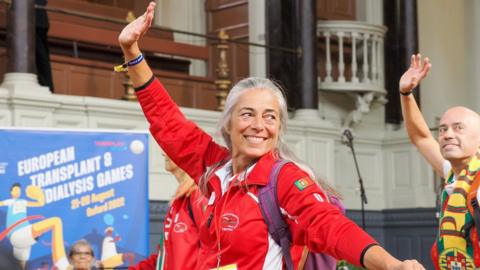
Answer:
top-left (129, 189), bottom-right (207, 270)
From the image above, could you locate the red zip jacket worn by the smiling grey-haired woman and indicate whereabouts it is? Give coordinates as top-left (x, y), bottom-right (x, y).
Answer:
top-left (133, 78), bottom-right (376, 269)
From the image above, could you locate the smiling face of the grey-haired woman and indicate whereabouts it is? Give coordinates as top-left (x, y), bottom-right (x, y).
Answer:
top-left (227, 88), bottom-right (281, 164)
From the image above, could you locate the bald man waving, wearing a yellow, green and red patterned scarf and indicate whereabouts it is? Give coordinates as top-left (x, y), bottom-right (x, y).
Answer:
top-left (399, 54), bottom-right (480, 270)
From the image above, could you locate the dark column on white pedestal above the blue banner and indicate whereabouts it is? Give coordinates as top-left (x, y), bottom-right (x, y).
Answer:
top-left (0, 0), bottom-right (53, 127)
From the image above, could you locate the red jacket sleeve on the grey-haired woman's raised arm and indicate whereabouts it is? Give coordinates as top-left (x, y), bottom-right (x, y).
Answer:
top-left (136, 79), bottom-right (229, 183)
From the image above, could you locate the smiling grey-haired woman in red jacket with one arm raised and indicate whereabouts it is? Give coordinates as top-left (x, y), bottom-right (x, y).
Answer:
top-left (119, 2), bottom-right (424, 270)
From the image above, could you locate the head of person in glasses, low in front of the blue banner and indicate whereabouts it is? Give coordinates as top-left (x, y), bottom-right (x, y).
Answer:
top-left (68, 239), bottom-right (103, 270)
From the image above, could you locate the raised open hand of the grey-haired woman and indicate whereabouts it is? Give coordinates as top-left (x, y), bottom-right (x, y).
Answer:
top-left (118, 2), bottom-right (155, 53)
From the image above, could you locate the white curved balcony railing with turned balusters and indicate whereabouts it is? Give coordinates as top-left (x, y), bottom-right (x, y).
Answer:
top-left (317, 21), bottom-right (386, 94)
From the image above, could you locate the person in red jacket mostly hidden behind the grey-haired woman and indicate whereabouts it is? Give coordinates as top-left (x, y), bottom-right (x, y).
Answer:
top-left (129, 156), bottom-right (207, 270)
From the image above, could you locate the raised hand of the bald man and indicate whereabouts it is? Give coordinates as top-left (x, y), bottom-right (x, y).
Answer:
top-left (399, 54), bottom-right (432, 94)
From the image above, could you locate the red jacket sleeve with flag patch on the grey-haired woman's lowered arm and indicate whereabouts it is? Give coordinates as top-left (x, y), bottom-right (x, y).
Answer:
top-left (277, 164), bottom-right (376, 266)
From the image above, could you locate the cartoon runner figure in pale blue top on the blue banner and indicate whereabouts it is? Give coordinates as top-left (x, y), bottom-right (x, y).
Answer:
top-left (0, 183), bottom-right (69, 270)
